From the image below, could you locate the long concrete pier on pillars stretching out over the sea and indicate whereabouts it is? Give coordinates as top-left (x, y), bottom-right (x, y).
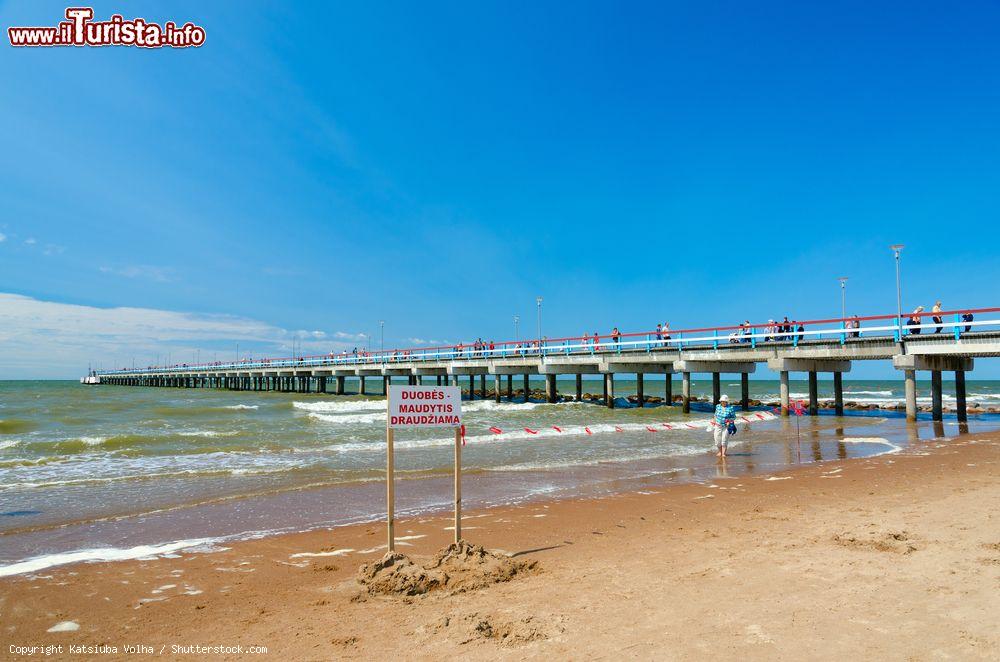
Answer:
top-left (96, 309), bottom-right (1000, 421)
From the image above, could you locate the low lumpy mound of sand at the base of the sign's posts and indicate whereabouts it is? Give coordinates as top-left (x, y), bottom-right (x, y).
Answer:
top-left (358, 540), bottom-right (538, 596)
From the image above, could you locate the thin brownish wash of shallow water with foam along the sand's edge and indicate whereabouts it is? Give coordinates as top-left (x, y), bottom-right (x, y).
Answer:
top-left (0, 417), bottom-right (920, 578)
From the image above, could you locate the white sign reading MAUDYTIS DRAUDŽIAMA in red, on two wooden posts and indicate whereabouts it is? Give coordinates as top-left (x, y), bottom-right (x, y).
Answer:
top-left (385, 385), bottom-right (462, 554)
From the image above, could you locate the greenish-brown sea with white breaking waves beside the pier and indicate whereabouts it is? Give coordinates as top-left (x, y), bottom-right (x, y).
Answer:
top-left (0, 376), bottom-right (1000, 577)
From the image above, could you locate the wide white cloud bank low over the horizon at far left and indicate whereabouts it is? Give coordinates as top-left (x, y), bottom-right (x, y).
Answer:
top-left (0, 292), bottom-right (347, 379)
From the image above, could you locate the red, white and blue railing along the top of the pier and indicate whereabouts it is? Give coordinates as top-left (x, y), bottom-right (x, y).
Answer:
top-left (97, 308), bottom-right (1000, 375)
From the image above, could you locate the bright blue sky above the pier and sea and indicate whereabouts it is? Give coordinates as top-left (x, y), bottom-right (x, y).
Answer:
top-left (0, 1), bottom-right (1000, 378)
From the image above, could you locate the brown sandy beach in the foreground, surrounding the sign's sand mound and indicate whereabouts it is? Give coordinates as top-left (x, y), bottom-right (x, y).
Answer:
top-left (0, 433), bottom-right (1000, 660)
